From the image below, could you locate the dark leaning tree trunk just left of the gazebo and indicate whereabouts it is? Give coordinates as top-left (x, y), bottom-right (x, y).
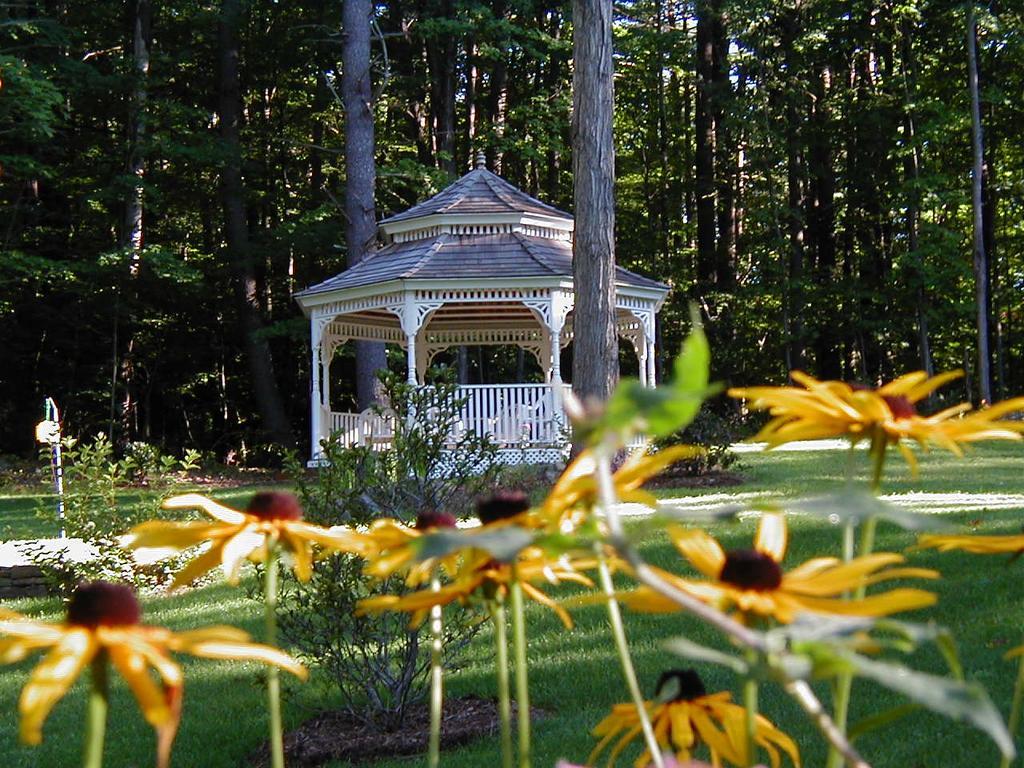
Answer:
top-left (218, 0), bottom-right (295, 445)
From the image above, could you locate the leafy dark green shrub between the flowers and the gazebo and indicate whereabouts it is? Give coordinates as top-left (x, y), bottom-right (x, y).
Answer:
top-left (279, 374), bottom-right (496, 730)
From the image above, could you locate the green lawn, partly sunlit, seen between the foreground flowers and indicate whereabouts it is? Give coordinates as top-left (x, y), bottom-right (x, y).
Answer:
top-left (0, 445), bottom-right (1024, 768)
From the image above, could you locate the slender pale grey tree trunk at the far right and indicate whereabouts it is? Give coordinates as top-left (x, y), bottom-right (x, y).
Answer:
top-left (967, 5), bottom-right (992, 402)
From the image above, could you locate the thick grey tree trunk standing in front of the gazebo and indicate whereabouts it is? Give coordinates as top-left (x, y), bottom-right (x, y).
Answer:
top-left (572, 0), bottom-right (618, 399)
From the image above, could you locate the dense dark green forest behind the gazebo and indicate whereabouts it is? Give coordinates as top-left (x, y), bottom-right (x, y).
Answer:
top-left (0, 0), bottom-right (1024, 460)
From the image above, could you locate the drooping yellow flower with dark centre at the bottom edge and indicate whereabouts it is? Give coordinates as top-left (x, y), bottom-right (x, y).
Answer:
top-left (587, 670), bottom-right (800, 768)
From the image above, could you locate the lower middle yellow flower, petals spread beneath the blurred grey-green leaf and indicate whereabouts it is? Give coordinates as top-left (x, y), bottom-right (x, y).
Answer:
top-left (355, 547), bottom-right (596, 628)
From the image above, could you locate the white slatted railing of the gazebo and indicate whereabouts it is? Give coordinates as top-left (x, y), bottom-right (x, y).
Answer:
top-left (327, 384), bottom-right (564, 449)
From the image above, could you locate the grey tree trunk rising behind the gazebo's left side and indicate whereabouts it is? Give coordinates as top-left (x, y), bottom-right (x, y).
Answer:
top-left (346, 0), bottom-right (387, 411)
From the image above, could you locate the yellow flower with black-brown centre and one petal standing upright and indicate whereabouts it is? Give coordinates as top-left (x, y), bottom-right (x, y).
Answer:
top-left (623, 514), bottom-right (939, 624)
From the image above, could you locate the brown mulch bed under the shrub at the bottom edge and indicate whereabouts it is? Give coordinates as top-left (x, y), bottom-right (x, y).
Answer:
top-left (249, 696), bottom-right (544, 768)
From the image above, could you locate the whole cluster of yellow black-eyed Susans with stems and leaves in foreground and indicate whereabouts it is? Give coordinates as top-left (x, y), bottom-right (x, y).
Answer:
top-left (0, 318), bottom-right (1024, 768)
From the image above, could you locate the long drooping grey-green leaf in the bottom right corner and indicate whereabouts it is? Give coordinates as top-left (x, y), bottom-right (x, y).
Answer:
top-left (848, 653), bottom-right (1016, 759)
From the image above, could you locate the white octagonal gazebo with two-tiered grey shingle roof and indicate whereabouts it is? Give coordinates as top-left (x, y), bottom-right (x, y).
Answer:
top-left (296, 159), bottom-right (669, 462)
